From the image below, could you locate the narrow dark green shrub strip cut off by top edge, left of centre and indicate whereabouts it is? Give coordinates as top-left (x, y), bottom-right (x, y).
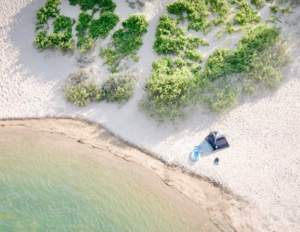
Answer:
top-left (69, 0), bottom-right (116, 13)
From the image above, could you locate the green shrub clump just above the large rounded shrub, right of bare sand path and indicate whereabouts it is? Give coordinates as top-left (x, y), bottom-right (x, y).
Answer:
top-left (153, 15), bottom-right (200, 54)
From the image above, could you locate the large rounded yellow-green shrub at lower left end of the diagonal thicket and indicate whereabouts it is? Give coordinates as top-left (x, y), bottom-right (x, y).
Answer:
top-left (140, 56), bottom-right (196, 121)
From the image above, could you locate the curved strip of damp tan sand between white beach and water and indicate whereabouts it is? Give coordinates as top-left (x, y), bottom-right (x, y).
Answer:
top-left (0, 116), bottom-right (263, 232)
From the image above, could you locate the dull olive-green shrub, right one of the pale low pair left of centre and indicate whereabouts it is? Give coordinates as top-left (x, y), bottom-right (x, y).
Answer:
top-left (102, 73), bottom-right (137, 103)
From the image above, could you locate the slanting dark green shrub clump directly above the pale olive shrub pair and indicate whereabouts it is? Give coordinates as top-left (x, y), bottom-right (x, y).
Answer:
top-left (100, 15), bottom-right (148, 73)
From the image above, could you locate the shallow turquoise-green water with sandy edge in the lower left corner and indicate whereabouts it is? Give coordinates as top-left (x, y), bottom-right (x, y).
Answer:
top-left (0, 129), bottom-right (218, 232)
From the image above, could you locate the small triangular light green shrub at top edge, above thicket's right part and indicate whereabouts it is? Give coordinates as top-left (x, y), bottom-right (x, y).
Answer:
top-left (234, 1), bottom-right (261, 25)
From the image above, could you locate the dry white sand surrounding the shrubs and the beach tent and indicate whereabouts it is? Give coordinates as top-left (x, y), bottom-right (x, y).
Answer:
top-left (0, 0), bottom-right (300, 232)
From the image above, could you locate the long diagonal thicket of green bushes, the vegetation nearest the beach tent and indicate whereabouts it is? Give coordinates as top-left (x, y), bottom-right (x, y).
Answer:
top-left (140, 22), bottom-right (288, 121)
